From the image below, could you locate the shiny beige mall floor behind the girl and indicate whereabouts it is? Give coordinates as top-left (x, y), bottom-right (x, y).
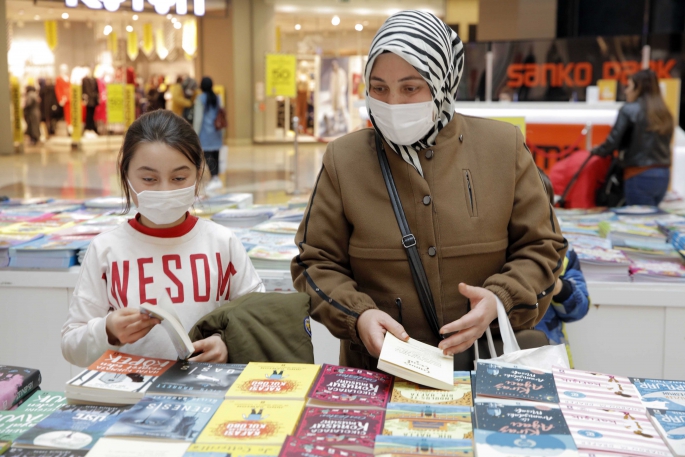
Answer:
top-left (0, 132), bottom-right (326, 204)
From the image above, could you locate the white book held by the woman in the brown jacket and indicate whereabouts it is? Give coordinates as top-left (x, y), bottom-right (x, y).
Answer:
top-left (378, 332), bottom-right (454, 390)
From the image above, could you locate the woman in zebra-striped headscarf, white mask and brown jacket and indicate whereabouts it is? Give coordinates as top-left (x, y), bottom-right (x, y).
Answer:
top-left (291, 11), bottom-right (567, 370)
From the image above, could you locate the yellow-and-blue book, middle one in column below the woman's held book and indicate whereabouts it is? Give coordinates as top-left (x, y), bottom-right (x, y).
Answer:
top-left (383, 403), bottom-right (473, 440)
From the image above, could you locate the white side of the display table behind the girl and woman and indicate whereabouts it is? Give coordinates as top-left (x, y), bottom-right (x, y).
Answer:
top-left (0, 267), bottom-right (685, 390)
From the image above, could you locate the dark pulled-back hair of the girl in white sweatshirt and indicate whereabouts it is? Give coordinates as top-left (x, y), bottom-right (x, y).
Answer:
top-left (117, 110), bottom-right (205, 213)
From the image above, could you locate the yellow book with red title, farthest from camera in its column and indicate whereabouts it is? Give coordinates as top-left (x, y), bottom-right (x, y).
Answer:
top-left (226, 362), bottom-right (319, 400)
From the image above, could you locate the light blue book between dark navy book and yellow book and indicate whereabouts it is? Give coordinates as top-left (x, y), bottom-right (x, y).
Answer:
top-left (105, 395), bottom-right (223, 443)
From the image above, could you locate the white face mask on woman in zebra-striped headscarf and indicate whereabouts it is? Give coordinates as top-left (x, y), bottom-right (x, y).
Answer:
top-left (369, 97), bottom-right (435, 145)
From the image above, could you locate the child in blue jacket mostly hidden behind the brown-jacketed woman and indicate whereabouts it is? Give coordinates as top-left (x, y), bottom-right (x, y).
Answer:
top-left (535, 168), bottom-right (590, 368)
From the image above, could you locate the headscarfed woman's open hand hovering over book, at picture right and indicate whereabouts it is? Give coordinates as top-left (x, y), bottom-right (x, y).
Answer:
top-left (438, 283), bottom-right (497, 355)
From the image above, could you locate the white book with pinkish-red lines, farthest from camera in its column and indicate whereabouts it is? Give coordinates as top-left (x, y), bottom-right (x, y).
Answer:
top-left (552, 367), bottom-right (645, 413)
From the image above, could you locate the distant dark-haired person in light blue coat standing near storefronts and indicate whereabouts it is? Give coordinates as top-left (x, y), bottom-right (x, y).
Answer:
top-left (193, 76), bottom-right (224, 190)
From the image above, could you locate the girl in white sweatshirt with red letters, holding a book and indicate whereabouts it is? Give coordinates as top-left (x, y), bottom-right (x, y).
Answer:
top-left (62, 110), bottom-right (264, 366)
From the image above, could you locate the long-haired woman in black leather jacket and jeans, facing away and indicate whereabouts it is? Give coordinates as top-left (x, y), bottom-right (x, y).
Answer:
top-left (592, 70), bottom-right (675, 206)
